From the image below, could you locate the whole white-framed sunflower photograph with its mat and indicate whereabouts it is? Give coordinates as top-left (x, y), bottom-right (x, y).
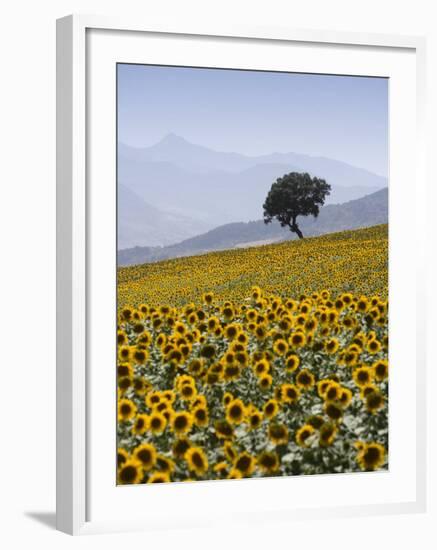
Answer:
top-left (57, 16), bottom-right (426, 534)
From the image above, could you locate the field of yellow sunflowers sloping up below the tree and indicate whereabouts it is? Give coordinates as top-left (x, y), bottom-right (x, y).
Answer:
top-left (117, 226), bottom-right (388, 484)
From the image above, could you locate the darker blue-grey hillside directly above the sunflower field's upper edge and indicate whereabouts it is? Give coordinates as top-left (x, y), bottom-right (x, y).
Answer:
top-left (118, 189), bottom-right (388, 265)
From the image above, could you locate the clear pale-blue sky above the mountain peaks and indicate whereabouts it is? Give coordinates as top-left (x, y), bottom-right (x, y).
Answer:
top-left (118, 64), bottom-right (388, 176)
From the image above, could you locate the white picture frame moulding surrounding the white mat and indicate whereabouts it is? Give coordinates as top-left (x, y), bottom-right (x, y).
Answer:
top-left (56, 15), bottom-right (426, 535)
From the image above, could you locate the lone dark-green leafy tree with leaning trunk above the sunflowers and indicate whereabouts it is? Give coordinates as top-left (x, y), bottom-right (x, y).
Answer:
top-left (263, 172), bottom-right (331, 239)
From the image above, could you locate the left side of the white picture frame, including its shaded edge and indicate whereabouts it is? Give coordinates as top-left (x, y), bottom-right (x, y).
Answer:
top-left (56, 16), bottom-right (86, 534)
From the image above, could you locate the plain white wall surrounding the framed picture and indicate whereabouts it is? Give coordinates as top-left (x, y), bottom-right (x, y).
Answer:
top-left (0, 0), bottom-right (437, 550)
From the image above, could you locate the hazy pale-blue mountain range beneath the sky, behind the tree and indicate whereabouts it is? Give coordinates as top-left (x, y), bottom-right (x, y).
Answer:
top-left (117, 134), bottom-right (387, 250)
